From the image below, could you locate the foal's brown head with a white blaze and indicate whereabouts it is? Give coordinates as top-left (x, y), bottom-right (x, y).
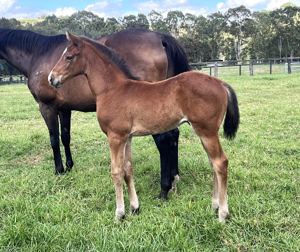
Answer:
top-left (48, 32), bottom-right (85, 88)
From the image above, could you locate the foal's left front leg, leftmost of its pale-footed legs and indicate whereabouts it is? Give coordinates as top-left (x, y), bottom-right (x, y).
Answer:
top-left (107, 133), bottom-right (127, 221)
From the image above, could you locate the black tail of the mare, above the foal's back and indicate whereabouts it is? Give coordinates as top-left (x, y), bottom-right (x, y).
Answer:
top-left (159, 33), bottom-right (190, 78)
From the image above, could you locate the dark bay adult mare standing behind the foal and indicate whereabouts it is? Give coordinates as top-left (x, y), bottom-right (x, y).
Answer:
top-left (0, 29), bottom-right (189, 198)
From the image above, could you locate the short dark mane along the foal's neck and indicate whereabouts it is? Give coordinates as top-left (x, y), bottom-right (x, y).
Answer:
top-left (80, 37), bottom-right (140, 80)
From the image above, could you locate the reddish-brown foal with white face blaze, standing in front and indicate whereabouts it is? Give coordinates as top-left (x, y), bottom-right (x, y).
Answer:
top-left (48, 33), bottom-right (239, 221)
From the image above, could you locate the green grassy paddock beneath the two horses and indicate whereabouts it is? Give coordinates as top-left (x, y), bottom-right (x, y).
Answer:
top-left (0, 74), bottom-right (300, 251)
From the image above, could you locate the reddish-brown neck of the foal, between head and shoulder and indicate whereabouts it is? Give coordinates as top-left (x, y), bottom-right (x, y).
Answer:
top-left (84, 43), bottom-right (129, 96)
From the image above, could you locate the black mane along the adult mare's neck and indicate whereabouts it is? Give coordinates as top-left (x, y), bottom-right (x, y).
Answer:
top-left (0, 29), bottom-right (67, 56)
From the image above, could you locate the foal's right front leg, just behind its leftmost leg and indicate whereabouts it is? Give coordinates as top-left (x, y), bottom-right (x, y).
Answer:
top-left (124, 137), bottom-right (139, 214)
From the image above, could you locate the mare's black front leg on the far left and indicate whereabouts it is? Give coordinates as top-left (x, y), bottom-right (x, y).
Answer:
top-left (39, 103), bottom-right (64, 174)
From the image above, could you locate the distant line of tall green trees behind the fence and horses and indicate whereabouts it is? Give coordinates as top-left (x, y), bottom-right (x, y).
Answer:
top-left (0, 3), bottom-right (300, 74)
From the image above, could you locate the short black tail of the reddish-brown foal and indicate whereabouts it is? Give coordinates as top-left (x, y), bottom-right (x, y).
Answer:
top-left (223, 83), bottom-right (240, 139)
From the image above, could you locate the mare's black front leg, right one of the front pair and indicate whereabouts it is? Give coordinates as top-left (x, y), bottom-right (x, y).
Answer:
top-left (59, 110), bottom-right (74, 171)
